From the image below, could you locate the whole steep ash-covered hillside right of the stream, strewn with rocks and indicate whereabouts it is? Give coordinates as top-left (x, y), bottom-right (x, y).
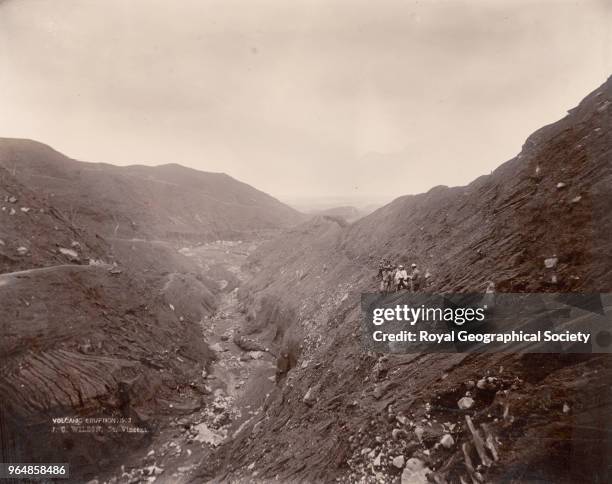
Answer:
top-left (207, 79), bottom-right (612, 483)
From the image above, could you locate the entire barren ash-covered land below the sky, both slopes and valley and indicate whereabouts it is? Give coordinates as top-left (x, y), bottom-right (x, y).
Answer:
top-left (0, 80), bottom-right (612, 484)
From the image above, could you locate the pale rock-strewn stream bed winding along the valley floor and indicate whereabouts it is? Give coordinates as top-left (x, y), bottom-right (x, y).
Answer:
top-left (93, 242), bottom-right (276, 484)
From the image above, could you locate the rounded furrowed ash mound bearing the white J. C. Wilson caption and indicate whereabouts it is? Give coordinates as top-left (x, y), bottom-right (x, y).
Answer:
top-left (0, 265), bottom-right (212, 482)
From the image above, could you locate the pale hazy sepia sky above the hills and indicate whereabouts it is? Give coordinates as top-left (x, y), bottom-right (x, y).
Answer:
top-left (0, 0), bottom-right (612, 200)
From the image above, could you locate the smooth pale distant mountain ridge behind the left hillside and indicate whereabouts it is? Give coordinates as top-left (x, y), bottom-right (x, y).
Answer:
top-left (0, 138), bottom-right (303, 241)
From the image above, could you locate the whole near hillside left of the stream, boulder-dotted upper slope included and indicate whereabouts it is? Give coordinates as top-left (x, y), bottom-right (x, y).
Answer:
top-left (0, 167), bottom-right (217, 482)
